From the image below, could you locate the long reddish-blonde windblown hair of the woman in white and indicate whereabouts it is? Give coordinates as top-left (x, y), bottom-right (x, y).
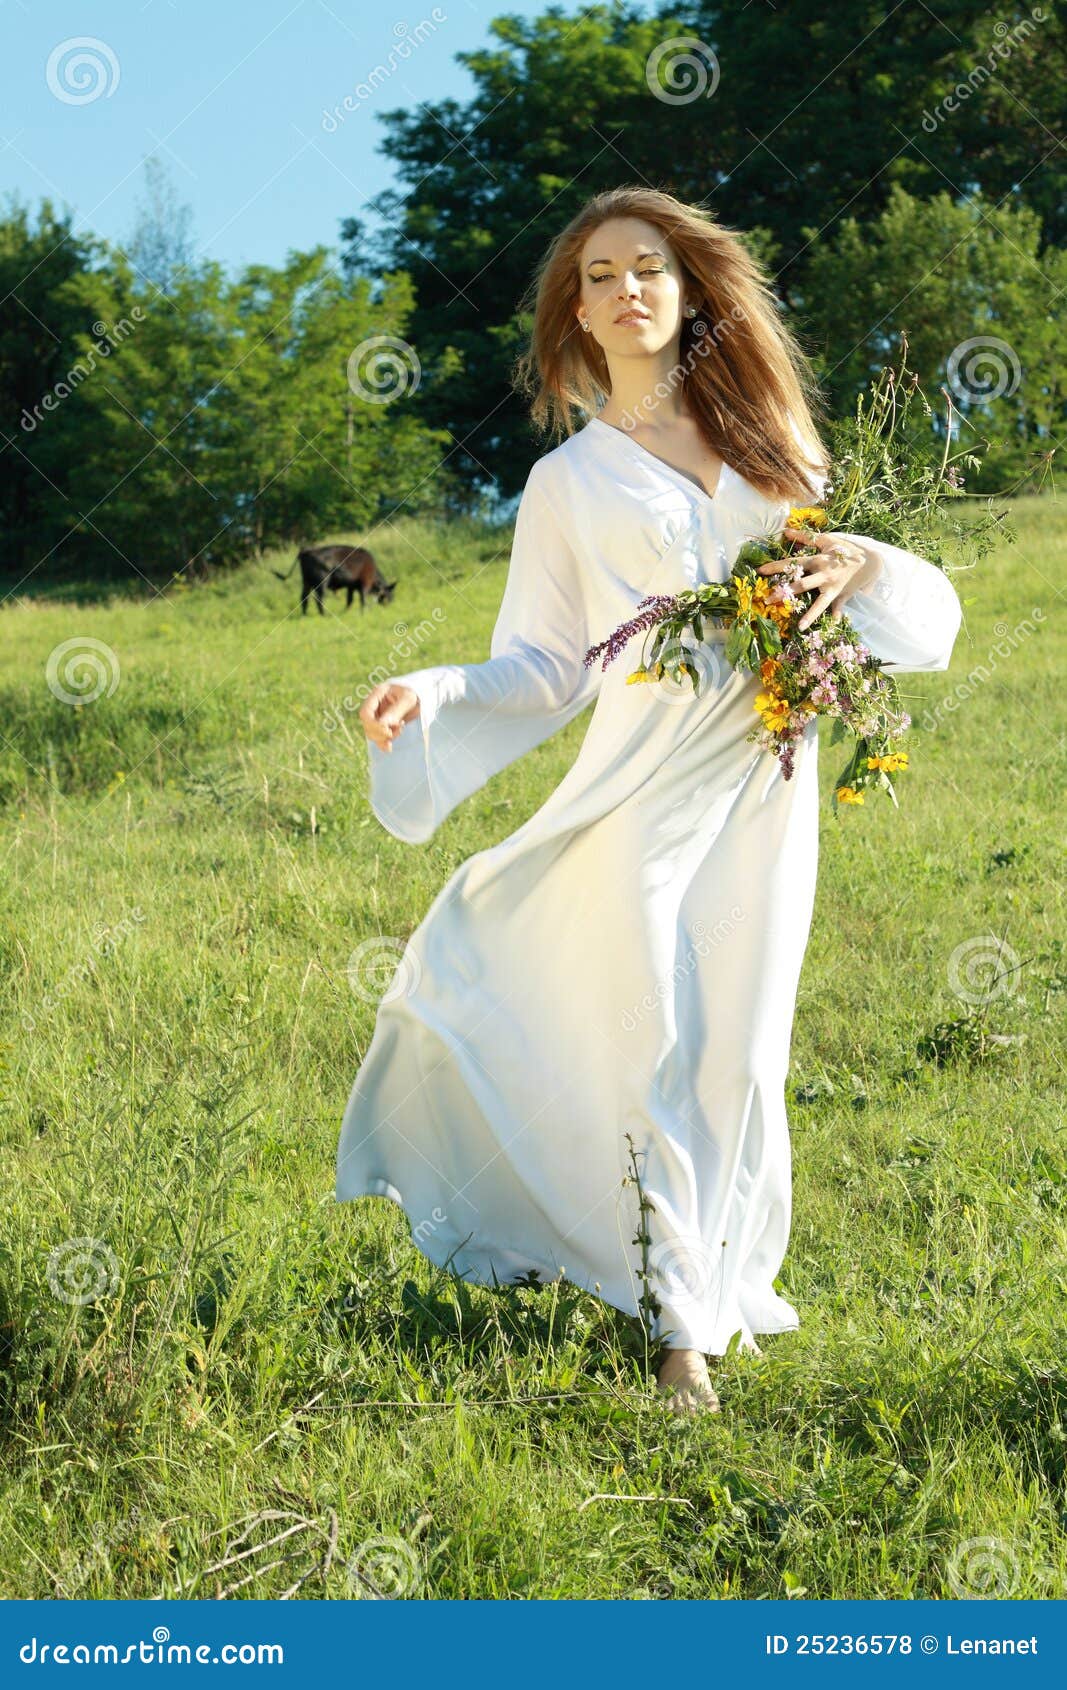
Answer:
top-left (514, 188), bottom-right (829, 499)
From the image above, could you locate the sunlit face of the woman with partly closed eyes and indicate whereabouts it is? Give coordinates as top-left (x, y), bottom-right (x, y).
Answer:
top-left (577, 216), bottom-right (685, 357)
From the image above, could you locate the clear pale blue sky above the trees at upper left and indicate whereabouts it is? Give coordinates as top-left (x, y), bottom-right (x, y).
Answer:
top-left (0, 0), bottom-right (564, 269)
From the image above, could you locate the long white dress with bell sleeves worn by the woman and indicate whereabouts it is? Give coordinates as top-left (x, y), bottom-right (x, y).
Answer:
top-left (337, 417), bottom-right (960, 1354)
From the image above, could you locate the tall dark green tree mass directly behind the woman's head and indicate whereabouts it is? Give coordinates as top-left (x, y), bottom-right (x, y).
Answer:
top-left (355, 0), bottom-right (1067, 493)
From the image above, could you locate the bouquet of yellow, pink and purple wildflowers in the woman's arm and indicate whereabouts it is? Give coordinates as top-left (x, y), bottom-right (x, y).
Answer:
top-left (585, 340), bottom-right (1003, 810)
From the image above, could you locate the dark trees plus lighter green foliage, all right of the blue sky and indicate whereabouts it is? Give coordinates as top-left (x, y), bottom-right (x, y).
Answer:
top-left (361, 0), bottom-right (1067, 493)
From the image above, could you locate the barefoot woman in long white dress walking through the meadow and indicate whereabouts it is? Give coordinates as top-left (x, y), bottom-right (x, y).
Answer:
top-left (337, 189), bottom-right (960, 1413)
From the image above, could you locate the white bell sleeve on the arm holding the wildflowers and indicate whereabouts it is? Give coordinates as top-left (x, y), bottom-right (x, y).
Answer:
top-left (790, 408), bottom-right (964, 674)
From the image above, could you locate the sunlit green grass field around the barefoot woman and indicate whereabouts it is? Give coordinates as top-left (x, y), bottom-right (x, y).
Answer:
top-left (0, 497), bottom-right (1067, 1599)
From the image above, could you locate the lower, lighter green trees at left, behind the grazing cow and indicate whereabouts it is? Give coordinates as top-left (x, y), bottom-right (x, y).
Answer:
top-left (0, 203), bottom-right (453, 585)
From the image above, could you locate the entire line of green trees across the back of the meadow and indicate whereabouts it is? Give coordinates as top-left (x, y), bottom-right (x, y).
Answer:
top-left (0, 0), bottom-right (1067, 576)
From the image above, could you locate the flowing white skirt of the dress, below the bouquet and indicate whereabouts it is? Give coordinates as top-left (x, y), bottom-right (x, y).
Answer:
top-left (337, 635), bottom-right (818, 1354)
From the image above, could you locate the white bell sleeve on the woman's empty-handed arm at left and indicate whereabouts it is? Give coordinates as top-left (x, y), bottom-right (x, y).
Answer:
top-left (367, 460), bottom-right (602, 845)
